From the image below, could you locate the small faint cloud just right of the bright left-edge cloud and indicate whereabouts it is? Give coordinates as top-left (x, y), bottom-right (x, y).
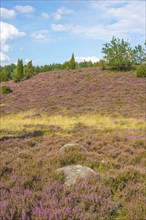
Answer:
top-left (32, 30), bottom-right (50, 41)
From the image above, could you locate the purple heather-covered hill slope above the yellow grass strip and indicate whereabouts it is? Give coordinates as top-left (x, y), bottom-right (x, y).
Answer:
top-left (0, 68), bottom-right (145, 117)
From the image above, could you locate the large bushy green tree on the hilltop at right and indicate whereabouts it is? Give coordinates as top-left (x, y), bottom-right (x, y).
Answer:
top-left (102, 37), bottom-right (134, 70)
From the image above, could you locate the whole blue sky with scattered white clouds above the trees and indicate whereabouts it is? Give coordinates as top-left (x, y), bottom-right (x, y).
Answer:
top-left (0, 0), bottom-right (146, 65)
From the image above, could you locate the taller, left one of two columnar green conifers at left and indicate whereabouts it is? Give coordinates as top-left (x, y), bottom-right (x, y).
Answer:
top-left (13, 60), bottom-right (23, 82)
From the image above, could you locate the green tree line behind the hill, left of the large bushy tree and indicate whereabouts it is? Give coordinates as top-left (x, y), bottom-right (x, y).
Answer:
top-left (0, 54), bottom-right (98, 82)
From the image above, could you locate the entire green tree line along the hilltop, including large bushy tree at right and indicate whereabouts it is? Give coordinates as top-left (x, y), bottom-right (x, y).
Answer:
top-left (0, 37), bottom-right (146, 82)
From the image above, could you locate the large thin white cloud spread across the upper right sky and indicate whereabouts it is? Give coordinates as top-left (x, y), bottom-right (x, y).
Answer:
top-left (51, 1), bottom-right (145, 40)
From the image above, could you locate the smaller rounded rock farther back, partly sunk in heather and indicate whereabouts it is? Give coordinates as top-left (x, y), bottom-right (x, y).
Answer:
top-left (59, 144), bottom-right (87, 154)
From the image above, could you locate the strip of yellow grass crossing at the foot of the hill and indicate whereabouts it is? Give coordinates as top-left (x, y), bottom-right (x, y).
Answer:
top-left (0, 111), bottom-right (146, 134)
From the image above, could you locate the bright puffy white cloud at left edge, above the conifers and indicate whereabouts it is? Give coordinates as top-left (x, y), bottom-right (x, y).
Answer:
top-left (0, 21), bottom-right (25, 62)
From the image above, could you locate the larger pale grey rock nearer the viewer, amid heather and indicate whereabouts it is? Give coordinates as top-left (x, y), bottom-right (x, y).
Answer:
top-left (57, 165), bottom-right (96, 186)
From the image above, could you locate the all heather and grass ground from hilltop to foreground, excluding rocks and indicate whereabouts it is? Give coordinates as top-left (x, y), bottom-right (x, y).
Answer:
top-left (0, 65), bottom-right (146, 220)
